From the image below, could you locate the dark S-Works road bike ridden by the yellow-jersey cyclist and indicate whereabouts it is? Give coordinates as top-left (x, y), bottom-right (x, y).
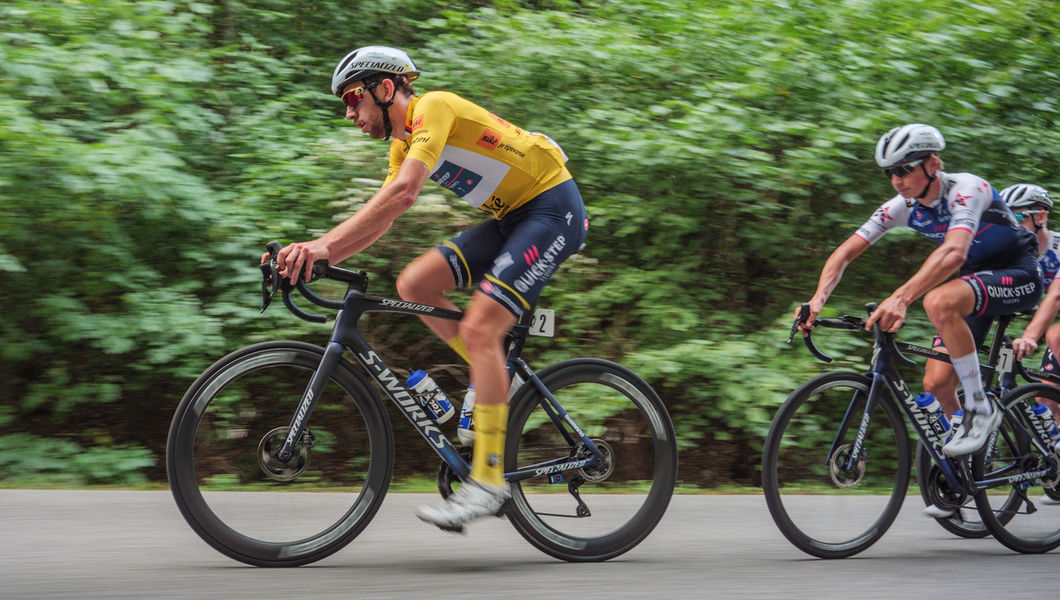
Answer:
top-left (166, 242), bottom-right (677, 566)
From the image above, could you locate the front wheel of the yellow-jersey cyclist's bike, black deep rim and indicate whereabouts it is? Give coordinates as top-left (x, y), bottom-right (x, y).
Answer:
top-left (165, 341), bottom-right (394, 567)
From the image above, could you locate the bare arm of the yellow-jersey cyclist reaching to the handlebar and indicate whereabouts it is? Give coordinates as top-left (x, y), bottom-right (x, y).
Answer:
top-left (269, 158), bottom-right (430, 281)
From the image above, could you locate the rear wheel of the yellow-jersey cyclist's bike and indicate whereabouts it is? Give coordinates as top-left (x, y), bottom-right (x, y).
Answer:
top-left (505, 358), bottom-right (677, 562)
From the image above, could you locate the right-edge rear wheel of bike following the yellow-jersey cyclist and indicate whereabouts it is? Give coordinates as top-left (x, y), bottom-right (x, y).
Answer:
top-left (972, 384), bottom-right (1060, 553)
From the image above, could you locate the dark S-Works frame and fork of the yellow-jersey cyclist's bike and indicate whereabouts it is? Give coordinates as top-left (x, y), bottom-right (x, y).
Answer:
top-left (278, 282), bottom-right (604, 481)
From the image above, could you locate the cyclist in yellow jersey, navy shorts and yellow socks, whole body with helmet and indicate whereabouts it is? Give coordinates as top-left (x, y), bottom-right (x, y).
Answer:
top-left (271, 46), bottom-right (588, 531)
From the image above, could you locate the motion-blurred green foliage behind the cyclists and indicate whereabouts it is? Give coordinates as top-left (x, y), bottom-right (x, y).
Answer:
top-left (0, 0), bottom-right (1060, 484)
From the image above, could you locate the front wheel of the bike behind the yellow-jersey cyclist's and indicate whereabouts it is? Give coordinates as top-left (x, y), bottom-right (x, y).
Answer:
top-left (762, 371), bottom-right (911, 559)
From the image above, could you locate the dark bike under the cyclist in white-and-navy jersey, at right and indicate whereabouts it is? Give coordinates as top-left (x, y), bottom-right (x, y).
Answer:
top-left (762, 304), bottom-right (1060, 559)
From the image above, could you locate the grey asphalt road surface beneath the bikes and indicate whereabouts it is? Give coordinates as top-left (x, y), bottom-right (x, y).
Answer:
top-left (0, 490), bottom-right (1060, 600)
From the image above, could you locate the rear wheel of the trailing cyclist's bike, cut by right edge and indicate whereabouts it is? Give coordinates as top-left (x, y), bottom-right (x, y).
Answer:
top-left (972, 383), bottom-right (1060, 553)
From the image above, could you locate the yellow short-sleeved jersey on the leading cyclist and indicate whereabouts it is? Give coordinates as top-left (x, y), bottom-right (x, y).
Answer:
top-left (383, 91), bottom-right (570, 218)
